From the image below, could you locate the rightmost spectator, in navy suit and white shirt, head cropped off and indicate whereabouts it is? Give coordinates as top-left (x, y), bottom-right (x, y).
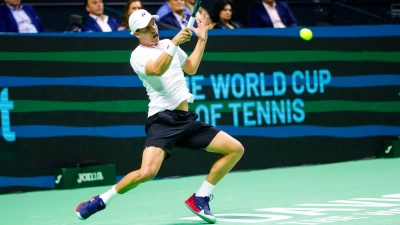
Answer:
top-left (250, 0), bottom-right (297, 28)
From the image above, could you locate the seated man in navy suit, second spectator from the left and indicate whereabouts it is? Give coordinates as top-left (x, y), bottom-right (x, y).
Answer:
top-left (81, 0), bottom-right (119, 32)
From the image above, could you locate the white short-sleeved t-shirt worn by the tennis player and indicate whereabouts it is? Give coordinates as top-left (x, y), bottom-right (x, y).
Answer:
top-left (130, 39), bottom-right (194, 116)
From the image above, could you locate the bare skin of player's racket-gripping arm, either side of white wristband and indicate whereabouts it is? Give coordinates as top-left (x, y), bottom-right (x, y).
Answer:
top-left (146, 28), bottom-right (192, 76)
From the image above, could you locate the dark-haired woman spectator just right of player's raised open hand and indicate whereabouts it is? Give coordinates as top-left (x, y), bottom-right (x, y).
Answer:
top-left (211, 0), bottom-right (243, 29)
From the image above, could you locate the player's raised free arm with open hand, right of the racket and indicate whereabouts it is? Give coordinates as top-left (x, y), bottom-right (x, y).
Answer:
top-left (182, 13), bottom-right (211, 75)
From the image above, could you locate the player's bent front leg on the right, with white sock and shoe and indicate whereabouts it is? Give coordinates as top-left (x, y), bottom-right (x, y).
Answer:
top-left (185, 131), bottom-right (244, 223)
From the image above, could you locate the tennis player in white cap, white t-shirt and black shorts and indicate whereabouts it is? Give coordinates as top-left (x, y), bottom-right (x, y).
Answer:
top-left (76, 10), bottom-right (244, 223)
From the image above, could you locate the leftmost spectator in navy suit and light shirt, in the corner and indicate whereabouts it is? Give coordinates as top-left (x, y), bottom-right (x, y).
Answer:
top-left (0, 0), bottom-right (46, 33)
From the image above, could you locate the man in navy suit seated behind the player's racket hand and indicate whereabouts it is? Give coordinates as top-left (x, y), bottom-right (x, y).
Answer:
top-left (160, 0), bottom-right (197, 29)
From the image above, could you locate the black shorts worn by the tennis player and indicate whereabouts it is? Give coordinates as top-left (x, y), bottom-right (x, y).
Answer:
top-left (145, 110), bottom-right (220, 158)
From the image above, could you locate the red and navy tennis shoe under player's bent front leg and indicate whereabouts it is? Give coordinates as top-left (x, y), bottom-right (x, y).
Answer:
top-left (185, 194), bottom-right (217, 223)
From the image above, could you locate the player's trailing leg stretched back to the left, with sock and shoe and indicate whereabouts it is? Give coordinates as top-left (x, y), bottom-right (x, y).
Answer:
top-left (76, 147), bottom-right (165, 220)
